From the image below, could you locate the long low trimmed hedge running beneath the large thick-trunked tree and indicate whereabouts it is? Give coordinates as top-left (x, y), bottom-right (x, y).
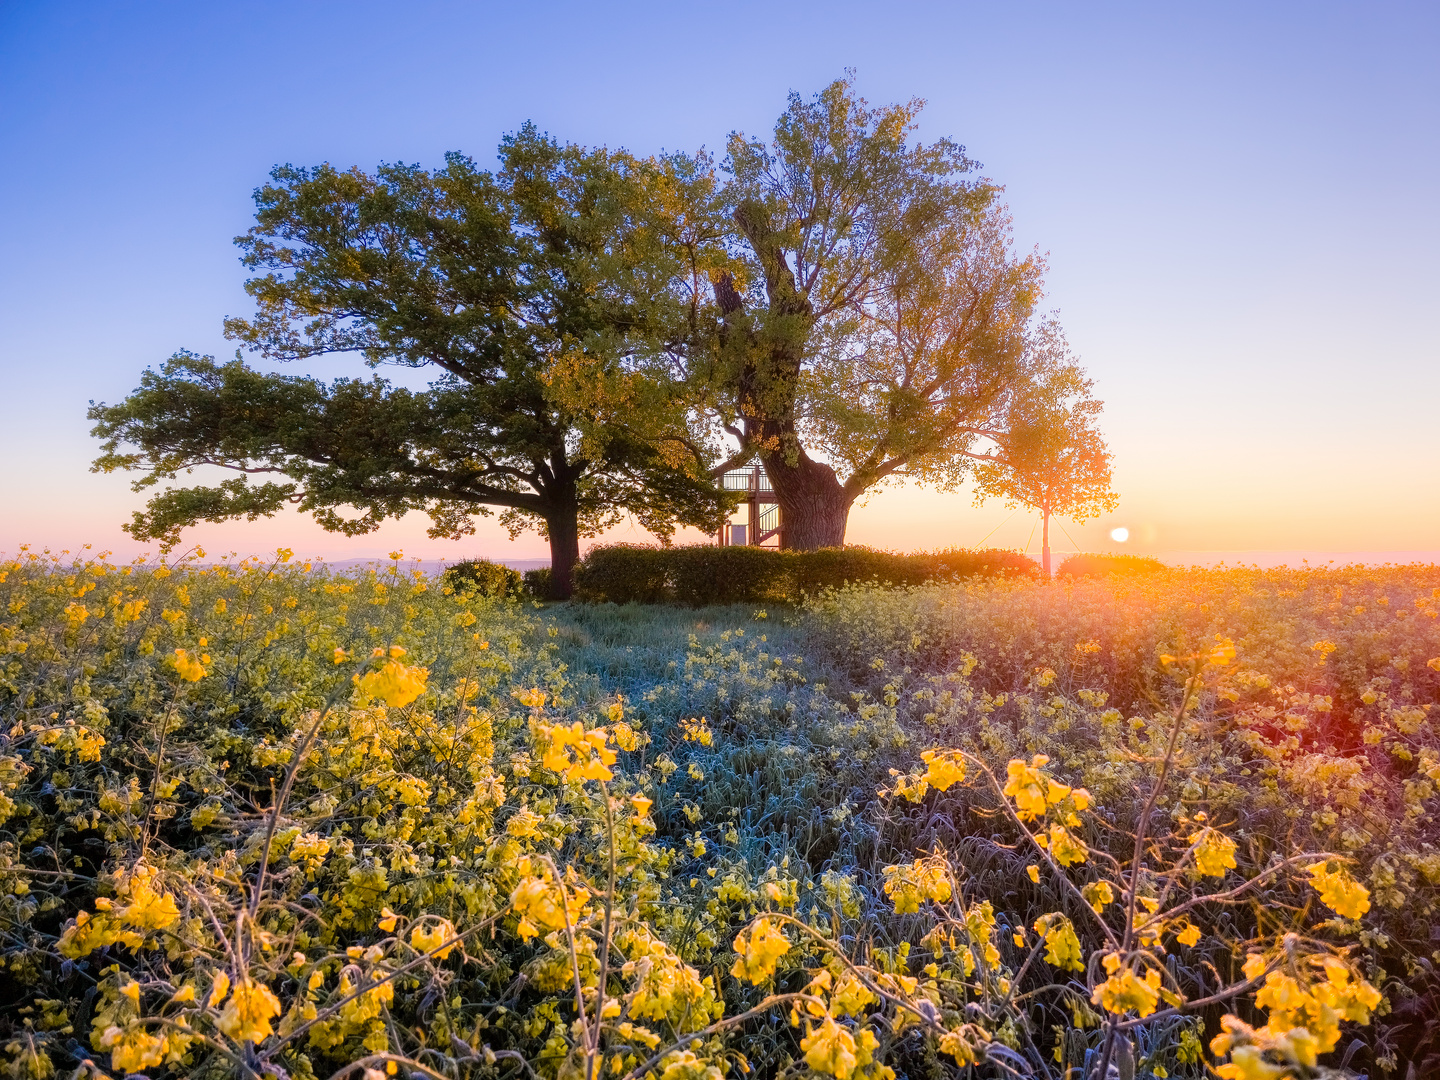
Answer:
top-left (575, 544), bottom-right (1040, 608)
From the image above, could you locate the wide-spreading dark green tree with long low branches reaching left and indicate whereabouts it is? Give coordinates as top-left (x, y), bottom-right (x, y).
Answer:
top-left (91, 127), bottom-right (724, 598)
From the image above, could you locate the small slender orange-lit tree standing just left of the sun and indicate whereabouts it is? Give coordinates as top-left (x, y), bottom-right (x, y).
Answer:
top-left (975, 352), bottom-right (1119, 579)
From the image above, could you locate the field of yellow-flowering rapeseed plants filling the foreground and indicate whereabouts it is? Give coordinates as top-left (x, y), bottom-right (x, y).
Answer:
top-left (0, 553), bottom-right (1422, 1080)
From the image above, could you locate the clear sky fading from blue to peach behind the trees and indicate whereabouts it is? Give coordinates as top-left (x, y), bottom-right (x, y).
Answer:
top-left (0, 0), bottom-right (1440, 567)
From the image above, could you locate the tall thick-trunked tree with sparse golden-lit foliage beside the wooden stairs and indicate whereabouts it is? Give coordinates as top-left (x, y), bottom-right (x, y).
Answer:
top-left (694, 81), bottom-right (1044, 549)
